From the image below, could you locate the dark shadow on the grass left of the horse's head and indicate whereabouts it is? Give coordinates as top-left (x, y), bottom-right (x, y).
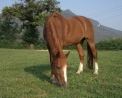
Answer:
top-left (24, 64), bottom-right (50, 82)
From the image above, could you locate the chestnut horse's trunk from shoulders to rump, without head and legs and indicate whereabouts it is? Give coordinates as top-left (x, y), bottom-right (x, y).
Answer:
top-left (43, 13), bottom-right (94, 46)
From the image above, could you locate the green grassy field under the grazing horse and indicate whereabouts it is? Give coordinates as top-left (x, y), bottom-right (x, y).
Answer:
top-left (0, 49), bottom-right (122, 98)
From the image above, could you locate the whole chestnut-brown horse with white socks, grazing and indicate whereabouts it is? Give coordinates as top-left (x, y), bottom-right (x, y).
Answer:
top-left (43, 12), bottom-right (98, 86)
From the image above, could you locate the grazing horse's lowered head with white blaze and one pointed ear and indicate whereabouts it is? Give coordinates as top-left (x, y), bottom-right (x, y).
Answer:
top-left (51, 52), bottom-right (70, 86)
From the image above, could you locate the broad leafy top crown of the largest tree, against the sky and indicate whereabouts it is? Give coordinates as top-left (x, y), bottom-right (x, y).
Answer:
top-left (2, 0), bottom-right (61, 26)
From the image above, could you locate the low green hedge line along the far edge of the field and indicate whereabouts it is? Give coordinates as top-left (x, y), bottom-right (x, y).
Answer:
top-left (0, 38), bottom-right (122, 50)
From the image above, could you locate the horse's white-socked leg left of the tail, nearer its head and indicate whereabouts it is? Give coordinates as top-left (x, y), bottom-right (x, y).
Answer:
top-left (76, 43), bottom-right (84, 74)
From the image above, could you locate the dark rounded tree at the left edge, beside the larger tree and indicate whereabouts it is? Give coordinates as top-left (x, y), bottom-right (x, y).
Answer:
top-left (0, 17), bottom-right (20, 41)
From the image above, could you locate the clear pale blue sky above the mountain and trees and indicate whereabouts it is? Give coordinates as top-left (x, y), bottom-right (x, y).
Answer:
top-left (0, 0), bottom-right (122, 31)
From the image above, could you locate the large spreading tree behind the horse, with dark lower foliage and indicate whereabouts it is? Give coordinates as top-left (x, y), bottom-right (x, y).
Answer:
top-left (2, 0), bottom-right (61, 44)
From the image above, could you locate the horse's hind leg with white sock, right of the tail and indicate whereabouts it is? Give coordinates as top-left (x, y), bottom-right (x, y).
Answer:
top-left (87, 40), bottom-right (98, 74)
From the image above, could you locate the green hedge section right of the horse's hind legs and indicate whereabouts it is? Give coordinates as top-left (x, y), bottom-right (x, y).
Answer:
top-left (96, 38), bottom-right (122, 50)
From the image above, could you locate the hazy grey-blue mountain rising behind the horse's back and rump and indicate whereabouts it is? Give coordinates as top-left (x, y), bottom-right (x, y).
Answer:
top-left (61, 9), bottom-right (122, 43)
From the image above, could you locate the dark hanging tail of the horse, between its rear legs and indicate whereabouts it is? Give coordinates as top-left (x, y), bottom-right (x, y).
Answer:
top-left (87, 43), bottom-right (93, 69)
